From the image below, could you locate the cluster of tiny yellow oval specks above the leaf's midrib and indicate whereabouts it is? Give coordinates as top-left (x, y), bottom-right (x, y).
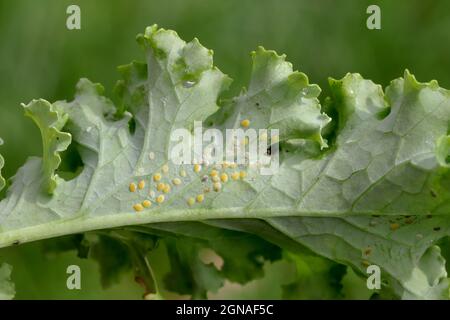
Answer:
top-left (129, 162), bottom-right (247, 212)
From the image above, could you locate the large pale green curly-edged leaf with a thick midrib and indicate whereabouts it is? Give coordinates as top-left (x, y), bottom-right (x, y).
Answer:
top-left (0, 26), bottom-right (450, 298)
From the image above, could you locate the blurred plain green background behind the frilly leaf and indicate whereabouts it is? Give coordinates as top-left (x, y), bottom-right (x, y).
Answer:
top-left (0, 0), bottom-right (450, 298)
